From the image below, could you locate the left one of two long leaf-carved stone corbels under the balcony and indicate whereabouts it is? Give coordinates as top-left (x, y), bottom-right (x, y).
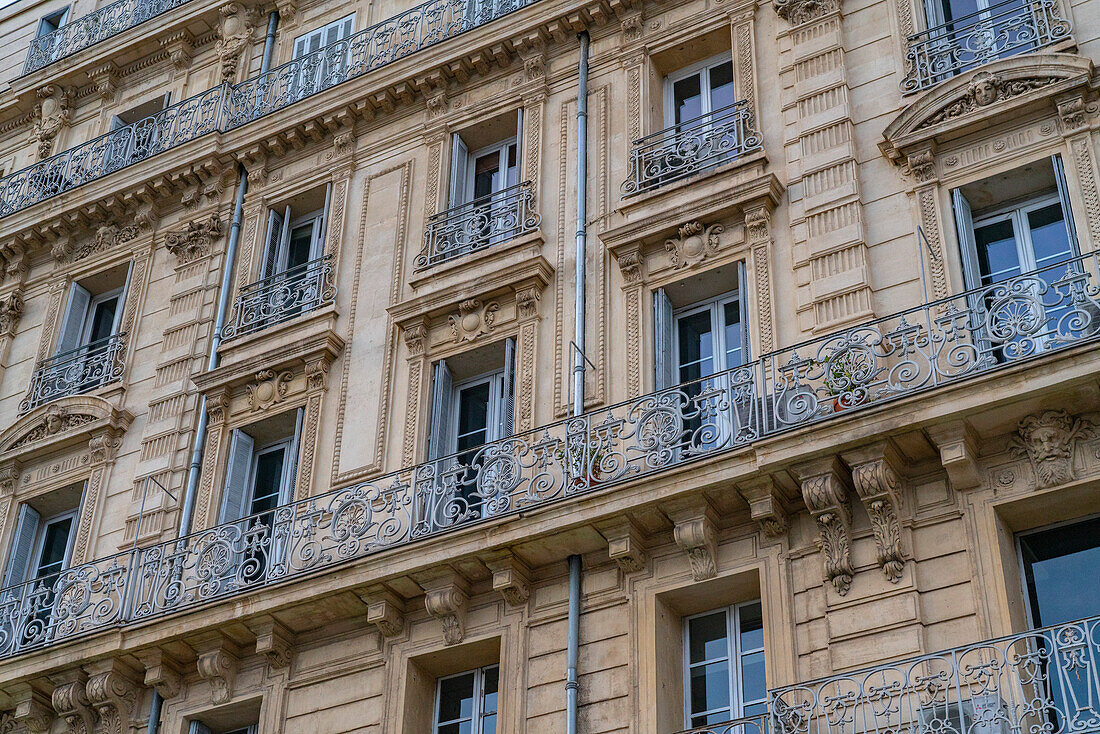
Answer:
top-left (792, 457), bottom-right (855, 596)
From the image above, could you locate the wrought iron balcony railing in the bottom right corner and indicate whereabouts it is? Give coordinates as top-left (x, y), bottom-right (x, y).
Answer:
top-left (770, 616), bottom-right (1100, 734)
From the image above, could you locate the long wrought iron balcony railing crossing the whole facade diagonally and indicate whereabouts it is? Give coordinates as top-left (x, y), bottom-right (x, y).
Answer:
top-left (0, 254), bottom-right (1100, 660)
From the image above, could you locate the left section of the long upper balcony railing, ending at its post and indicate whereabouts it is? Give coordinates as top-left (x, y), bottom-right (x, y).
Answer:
top-left (0, 87), bottom-right (226, 217)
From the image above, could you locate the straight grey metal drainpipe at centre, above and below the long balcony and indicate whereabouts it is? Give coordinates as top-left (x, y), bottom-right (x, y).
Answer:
top-left (565, 32), bottom-right (589, 734)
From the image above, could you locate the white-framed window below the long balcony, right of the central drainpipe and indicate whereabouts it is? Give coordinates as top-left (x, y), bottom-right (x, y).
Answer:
top-left (684, 601), bottom-right (768, 728)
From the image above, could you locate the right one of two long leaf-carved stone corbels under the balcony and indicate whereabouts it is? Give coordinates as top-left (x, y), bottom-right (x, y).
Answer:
top-left (842, 441), bottom-right (905, 583)
